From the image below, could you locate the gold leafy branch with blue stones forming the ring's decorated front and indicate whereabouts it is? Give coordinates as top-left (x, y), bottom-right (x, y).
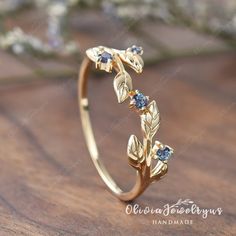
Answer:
top-left (87, 46), bottom-right (173, 182)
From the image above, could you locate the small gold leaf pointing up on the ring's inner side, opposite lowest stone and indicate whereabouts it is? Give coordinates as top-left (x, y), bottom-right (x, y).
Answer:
top-left (127, 135), bottom-right (144, 167)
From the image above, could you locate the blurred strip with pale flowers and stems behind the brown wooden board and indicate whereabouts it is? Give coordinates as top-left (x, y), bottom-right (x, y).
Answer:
top-left (0, 0), bottom-right (236, 82)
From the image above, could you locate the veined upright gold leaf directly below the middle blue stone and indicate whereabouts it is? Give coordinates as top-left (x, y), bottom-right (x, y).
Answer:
top-left (141, 101), bottom-right (160, 139)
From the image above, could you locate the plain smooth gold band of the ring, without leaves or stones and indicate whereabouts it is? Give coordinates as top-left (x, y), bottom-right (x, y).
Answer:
top-left (78, 57), bottom-right (148, 201)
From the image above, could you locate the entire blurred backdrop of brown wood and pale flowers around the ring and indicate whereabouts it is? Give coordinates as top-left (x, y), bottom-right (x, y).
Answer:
top-left (0, 0), bottom-right (236, 236)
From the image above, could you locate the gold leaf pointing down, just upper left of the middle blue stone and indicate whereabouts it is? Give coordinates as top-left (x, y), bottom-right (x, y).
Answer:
top-left (113, 72), bottom-right (132, 103)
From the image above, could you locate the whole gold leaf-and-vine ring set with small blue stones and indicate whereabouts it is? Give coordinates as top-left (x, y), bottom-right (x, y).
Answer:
top-left (78, 46), bottom-right (173, 201)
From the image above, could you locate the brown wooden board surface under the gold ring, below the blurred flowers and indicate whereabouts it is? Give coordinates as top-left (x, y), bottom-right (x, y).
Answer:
top-left (0, 54), bottom-right (236, 236)
